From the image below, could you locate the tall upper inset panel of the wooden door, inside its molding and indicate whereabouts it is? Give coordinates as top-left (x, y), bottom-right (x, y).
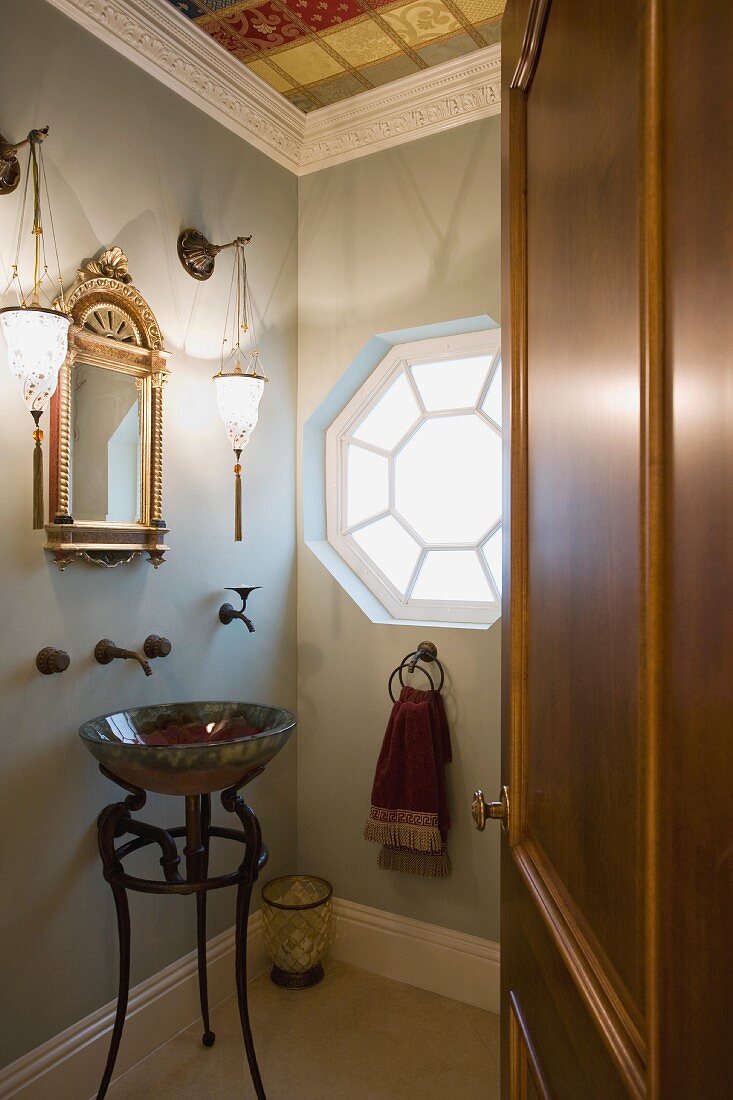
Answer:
top-left (524, 0), bottom-right (644, 1024)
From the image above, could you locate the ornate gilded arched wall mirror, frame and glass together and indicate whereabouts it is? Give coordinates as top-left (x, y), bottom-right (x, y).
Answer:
top-left (46, 248), bottom-right (168, 569)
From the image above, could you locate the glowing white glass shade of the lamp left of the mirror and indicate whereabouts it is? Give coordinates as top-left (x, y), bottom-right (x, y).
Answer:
top-left (0, 306), bottom-right (72, 413)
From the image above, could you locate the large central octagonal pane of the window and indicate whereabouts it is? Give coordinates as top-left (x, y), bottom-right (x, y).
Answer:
top-left (395, 414), bottom-right (502, 543)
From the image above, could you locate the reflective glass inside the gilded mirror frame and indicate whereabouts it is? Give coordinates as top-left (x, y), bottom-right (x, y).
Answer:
top-left (72, 361), bottom-right (142, 524)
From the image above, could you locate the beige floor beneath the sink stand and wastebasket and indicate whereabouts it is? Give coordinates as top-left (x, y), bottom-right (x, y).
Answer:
top-left (108, 960), bottom-right (499, 1100)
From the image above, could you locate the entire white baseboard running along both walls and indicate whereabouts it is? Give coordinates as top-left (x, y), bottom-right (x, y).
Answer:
top-left (0, 899), bottom-right (500, 1100)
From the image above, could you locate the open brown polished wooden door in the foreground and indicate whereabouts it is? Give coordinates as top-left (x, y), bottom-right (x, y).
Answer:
top-left (490, 0), bottom-right (733, 1100)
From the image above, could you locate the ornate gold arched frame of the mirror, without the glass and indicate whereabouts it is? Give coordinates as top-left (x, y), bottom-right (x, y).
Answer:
top-left (46, 246), bottom-right (168, 570)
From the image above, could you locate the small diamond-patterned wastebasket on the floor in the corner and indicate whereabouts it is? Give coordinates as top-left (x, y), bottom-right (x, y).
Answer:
top-left (262, 875), bottom-right (333, 989)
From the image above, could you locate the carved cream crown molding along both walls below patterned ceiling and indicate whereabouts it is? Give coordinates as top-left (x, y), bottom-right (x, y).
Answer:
top-left (39, 0), bottom-right (501, 176)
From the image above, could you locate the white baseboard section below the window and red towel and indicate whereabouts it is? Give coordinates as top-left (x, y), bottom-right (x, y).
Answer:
top-left (331, 899), bottom-right (500, 1013)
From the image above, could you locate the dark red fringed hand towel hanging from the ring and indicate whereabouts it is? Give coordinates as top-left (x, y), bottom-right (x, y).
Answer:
top-left (364, 688), bottom-right (451, 878)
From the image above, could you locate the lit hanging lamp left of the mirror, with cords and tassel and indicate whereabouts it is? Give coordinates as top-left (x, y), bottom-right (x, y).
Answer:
top-left (0, 127), bottom-right (72, 530)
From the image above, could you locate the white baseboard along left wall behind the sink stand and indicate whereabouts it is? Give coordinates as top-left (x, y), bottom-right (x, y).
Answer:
top-left (0, 912), bottom-right (269, 1100)
